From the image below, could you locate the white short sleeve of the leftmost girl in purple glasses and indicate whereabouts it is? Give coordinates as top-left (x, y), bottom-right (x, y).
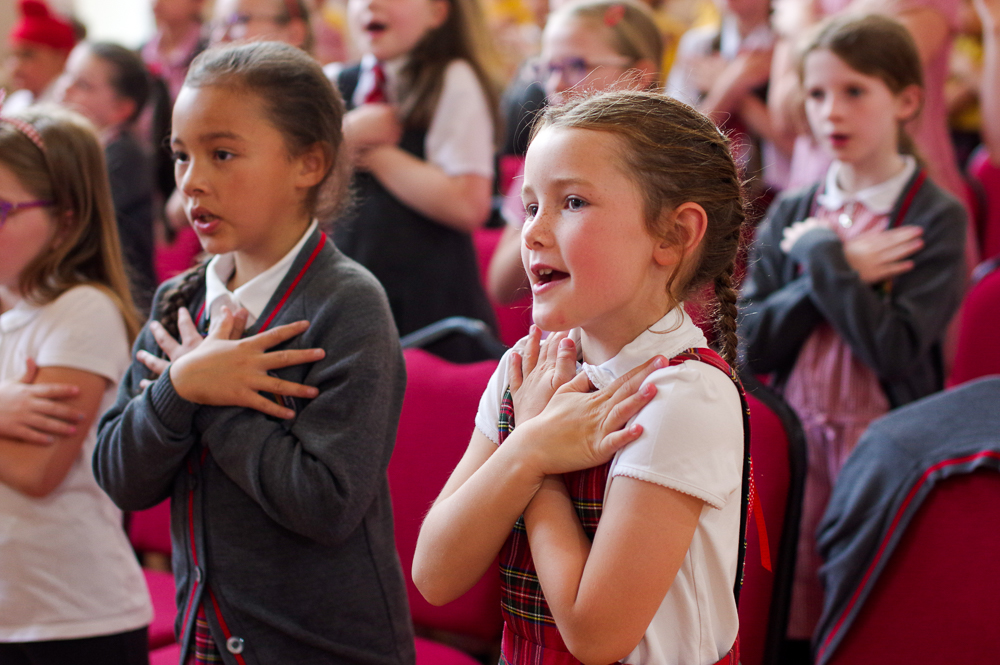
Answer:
top-left (35, 286), bottom-right (130, 384)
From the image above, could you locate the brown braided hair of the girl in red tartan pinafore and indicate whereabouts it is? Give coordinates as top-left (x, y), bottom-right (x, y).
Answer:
top-left (534, 91), bottom-right (746, 364)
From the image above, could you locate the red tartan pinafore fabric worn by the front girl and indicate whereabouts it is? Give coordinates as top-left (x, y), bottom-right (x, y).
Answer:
top-left (497, 349), bottom-right (743, 665)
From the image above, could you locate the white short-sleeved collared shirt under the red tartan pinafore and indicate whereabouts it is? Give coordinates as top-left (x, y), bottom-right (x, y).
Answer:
top-left (476, 308), bottom-right (743, 665)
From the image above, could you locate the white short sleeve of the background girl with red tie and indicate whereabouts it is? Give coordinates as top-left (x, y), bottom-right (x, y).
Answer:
top-left (425, 60), bottom-right (495, 178)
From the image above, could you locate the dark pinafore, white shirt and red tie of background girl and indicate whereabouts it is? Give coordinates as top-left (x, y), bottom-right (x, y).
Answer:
top-left (334, 57), bottom-right (496, 362)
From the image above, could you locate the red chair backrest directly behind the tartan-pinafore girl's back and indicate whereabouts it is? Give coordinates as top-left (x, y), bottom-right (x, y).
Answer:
top-left (739, 374), bottom-right (806, 665)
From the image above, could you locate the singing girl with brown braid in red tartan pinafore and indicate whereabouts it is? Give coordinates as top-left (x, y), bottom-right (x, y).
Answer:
top-left (413, 91), bottom-right (746, 665)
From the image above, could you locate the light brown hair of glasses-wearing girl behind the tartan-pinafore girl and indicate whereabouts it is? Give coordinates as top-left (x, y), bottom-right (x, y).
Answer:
top-left (549, 0), bottom-right (663, 79)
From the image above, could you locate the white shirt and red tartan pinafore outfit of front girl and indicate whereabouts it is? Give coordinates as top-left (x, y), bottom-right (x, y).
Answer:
top-left (476, 307), bottom-right (746, 665)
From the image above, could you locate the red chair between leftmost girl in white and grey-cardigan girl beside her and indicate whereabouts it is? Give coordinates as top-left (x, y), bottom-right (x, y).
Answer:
top-left (128, 499), bottom-right (177, 649)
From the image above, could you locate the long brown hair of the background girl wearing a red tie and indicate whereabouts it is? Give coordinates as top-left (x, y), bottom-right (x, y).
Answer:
top-left (400, 0), bottom-right (501, 138)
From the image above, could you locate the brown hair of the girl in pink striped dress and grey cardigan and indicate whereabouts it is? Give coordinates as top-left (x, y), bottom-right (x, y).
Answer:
top-left (798, 14), bottom-right (924, 156)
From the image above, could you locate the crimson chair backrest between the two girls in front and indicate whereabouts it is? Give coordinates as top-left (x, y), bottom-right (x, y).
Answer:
top-left (389, 349), bottom-right (503, 642)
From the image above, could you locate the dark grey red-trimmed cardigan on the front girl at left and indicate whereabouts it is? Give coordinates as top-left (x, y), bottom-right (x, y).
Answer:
top-left (94, 232), bottom-right (414, 665)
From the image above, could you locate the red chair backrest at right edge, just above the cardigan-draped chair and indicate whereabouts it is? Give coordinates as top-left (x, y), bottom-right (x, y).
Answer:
top-left (948, 257), bottom-right (1000, 386)
